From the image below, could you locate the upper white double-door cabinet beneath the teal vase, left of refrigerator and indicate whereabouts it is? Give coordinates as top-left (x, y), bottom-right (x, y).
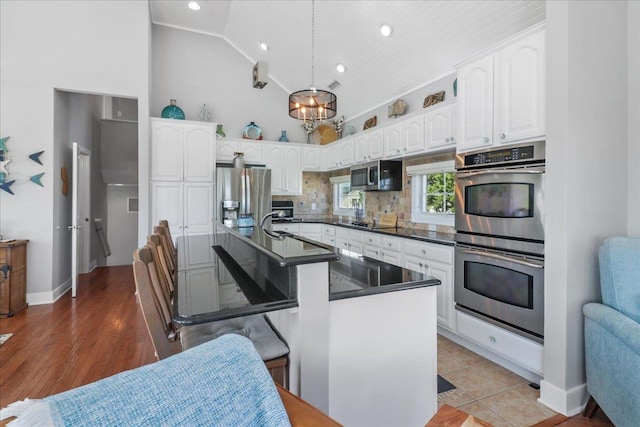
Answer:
top-left (151, 118), bottom-right (215, 182)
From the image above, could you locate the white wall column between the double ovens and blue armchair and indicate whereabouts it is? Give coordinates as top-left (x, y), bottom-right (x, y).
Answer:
top-left (540, 1), bottom-right (640, 414)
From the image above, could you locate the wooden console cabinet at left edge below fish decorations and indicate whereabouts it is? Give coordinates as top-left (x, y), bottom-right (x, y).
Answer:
top-left (0, 240), bottom-right (29, 317)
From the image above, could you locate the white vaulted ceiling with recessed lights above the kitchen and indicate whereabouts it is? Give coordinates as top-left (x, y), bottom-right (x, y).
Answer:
top-left (150, 0), bottom-right (545, 120)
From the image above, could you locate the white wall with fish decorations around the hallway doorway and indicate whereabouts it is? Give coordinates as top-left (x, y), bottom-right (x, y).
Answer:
top-left (0, 1), bottom-right (150, 304)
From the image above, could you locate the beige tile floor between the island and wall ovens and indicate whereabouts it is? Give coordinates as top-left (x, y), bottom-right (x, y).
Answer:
top-left (438, 335), bottom-right (556, 427)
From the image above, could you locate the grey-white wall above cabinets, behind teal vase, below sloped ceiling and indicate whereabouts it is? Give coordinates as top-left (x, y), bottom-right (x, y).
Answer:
top-left (151, 25), bottom-right (307, 142)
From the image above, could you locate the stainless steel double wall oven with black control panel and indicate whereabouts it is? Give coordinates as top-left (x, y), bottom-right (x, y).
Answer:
top-left (454, 141), bottom-right (545, 342)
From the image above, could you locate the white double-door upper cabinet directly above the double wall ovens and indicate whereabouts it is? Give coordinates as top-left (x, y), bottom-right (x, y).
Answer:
top-left (457, 28), bottom-right (545, 152)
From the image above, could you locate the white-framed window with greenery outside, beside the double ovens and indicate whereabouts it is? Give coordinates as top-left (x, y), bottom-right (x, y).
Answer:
top-left (407, 161), bottom-right (455, 226)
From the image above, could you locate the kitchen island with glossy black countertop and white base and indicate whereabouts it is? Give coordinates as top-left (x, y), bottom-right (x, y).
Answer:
top-left (174, 225), bottom-right (439, 426)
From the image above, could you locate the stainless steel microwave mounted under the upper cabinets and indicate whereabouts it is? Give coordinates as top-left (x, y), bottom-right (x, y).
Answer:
top-left (351, 160), bottom-right (402, 191)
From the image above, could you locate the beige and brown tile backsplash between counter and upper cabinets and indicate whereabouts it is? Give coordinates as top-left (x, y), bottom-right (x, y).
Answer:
top-left (273, 151), bottom-right (455, 233)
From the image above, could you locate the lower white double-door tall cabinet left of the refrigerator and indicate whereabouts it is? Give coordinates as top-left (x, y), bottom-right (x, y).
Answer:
top-left (151, 182), bottom-right (213, 238)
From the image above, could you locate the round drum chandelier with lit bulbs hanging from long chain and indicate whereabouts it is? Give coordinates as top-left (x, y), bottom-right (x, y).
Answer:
top-left (289, 0), bottom-right (338, 123)
